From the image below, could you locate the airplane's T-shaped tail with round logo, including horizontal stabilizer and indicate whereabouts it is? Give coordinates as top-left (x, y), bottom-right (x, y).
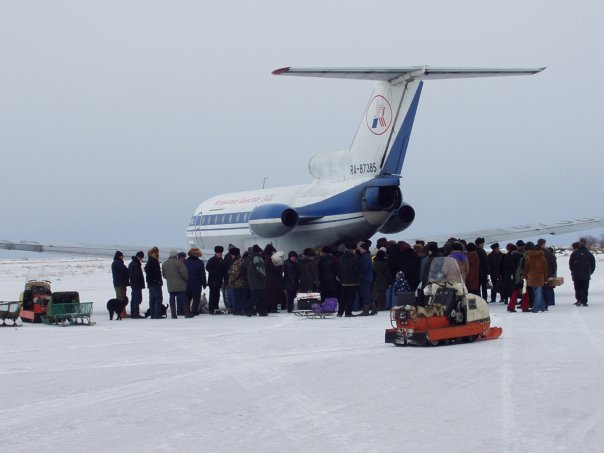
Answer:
top-left (273, 66), bottom-right (545, 179)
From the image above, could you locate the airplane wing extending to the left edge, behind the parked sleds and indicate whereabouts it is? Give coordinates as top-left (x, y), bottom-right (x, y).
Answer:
top-left (0, 240), bottom-right (185, 257)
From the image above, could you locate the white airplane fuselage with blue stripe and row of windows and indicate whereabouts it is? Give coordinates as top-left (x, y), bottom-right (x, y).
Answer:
top-left (187, 176), bottom-right (399, 251)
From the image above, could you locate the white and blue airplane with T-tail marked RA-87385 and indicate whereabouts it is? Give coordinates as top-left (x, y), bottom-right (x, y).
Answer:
top-left (0, 66), bottom-right (604, 256)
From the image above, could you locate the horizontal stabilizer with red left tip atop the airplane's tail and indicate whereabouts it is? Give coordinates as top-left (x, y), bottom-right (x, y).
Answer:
top-left (273, 66), bottom-right (545, 84)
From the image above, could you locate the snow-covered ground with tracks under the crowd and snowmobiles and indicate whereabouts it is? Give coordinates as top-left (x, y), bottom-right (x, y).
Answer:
top-left (0, 252), bottom-right (604, 452)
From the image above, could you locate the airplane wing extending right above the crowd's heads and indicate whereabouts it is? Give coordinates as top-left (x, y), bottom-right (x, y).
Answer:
top-left (407, 216), bottom-right (604, 245)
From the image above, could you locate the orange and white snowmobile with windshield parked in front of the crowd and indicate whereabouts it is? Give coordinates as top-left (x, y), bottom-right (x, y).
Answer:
top-left (385, 257), bottom-right (503, 346)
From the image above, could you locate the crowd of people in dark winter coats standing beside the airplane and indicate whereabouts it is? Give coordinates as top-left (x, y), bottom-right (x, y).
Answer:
top-left (111, 238), bottom-right (595, 319)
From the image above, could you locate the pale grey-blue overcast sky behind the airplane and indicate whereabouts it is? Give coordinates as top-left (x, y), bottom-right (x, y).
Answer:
top-left (0, 0), bottom-right (604, 251)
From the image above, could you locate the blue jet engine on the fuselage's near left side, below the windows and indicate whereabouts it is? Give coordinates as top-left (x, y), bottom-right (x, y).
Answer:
top-left (248, 203), bottom-right (298, 238)
